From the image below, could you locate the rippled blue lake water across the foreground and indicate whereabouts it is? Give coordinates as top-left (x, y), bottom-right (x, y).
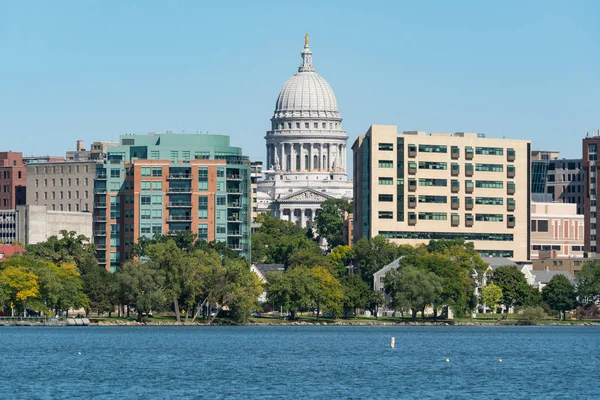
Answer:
top-left (0, 326), bottom-right (600, 400)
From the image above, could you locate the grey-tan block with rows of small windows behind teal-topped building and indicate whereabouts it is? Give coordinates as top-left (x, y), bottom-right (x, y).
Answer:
top-left (27, 161), bottom-right (96, 212)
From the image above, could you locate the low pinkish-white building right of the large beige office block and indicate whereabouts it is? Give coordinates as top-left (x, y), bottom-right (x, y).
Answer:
top-left (531, 203), bottom-right (585, 260)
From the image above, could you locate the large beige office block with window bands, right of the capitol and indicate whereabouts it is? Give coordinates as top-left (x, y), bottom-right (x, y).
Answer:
top-left (352, 125), bottom-right (531, 261)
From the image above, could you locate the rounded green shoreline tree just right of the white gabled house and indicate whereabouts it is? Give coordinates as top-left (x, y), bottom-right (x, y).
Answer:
top-left (385, 265), bottom-right (443, 321)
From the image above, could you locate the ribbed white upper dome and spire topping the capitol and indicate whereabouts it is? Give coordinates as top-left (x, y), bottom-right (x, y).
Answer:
top-left (273, 40), bottom-right (340, 119)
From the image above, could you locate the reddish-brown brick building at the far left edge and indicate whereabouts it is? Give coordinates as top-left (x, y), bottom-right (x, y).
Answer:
top-left (0, 151), bottom-right (26, 210)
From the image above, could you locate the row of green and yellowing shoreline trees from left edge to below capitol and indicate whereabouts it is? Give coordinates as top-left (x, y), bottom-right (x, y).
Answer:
top-left (0, 232), bottom-right (263, 323)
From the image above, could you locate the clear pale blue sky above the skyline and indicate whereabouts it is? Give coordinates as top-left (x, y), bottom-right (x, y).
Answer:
top-left (0, 0), bottom-right (600, 159)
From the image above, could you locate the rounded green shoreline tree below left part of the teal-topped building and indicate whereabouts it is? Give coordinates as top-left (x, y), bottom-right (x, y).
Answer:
top-left (117, 261), bottom-right (167, 322)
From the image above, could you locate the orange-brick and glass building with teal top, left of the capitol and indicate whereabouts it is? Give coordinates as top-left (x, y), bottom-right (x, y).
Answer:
top-left (94, 134), bottom-right (251, 271)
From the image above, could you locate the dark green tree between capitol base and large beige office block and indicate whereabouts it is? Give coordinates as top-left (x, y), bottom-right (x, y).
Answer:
top-left (315, 199), bottom-right (352, 249)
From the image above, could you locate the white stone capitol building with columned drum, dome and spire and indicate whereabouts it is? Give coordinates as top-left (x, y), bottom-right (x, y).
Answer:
top-left (257, 35), bottom-right (352, 227)
